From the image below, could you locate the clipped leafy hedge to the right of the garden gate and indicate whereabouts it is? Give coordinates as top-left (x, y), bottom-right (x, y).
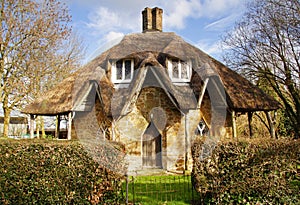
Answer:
top-left (192, 138), bottom-right (300, 204)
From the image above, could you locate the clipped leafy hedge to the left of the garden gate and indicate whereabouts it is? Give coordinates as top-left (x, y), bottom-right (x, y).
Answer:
top-left (0, 140), bottom-right (124, 204)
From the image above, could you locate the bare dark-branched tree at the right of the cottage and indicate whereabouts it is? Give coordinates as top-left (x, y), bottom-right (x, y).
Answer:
top-left (223, 0), bottom-right (300, 138)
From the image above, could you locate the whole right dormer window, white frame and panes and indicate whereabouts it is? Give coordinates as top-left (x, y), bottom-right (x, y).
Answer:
top-left (167, 59), bottom-right (192, 83)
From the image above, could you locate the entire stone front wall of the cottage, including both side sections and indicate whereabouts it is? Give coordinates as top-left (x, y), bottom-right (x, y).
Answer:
top-left (72, 87), bottom-right (231, 171)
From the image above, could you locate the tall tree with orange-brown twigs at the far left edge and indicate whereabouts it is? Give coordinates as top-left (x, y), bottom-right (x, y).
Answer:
top-left (0, 0), bottom-right (82, 136)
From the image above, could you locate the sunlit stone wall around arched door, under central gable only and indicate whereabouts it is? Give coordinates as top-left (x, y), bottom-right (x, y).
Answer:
top-left (115, 87), bottom-right (185, 170)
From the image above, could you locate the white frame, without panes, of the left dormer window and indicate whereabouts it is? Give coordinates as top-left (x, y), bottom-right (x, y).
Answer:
top-left (111, 59), bottom-right (134, 83)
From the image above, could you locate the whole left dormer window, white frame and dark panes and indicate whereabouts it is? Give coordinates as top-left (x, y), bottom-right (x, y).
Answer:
top-left (111, 59), bottom-right (134, 83)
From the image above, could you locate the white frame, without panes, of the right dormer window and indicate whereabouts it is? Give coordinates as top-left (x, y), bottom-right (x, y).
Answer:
top-left (167, 59), bottom-right (192, 83)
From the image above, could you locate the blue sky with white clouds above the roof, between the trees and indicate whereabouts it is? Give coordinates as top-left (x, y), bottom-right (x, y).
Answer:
top-left (63, 0), bottom-right (246, 61)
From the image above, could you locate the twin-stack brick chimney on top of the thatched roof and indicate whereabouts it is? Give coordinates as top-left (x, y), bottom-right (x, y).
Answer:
top-left (142, 7), bottom-right (163, 33)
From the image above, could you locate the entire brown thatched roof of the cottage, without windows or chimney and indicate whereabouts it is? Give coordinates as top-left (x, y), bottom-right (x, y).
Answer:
top-left (23, 32), bottom-right (279, 115)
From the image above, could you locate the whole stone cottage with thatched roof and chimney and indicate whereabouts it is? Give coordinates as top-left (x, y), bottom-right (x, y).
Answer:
top-left (23, 8), bottom-right (278, 171)
